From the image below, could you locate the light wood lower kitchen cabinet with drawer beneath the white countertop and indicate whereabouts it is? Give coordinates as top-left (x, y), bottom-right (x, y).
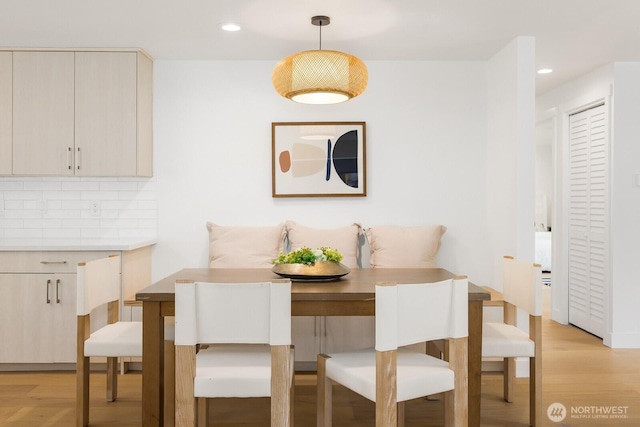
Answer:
top-left (0, 246), bottom-right (151, 370)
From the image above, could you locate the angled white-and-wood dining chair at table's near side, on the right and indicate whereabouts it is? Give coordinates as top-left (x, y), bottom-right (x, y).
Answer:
top-left (317, 277), bottom-right (468, 427)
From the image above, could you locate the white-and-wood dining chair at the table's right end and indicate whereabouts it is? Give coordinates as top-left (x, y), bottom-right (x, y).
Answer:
top-left (482, 256), bottom-right (543, 426)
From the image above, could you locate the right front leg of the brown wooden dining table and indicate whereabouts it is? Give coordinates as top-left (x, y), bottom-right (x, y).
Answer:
top-left (468, 301), bottom-right (482, 427)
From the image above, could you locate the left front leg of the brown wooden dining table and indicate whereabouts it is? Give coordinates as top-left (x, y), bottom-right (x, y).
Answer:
top-left (142, 301), bottom-right (164, 427)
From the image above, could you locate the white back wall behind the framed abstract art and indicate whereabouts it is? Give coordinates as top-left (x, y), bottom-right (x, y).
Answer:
top-left (153, 61), bottom-right (492, 285)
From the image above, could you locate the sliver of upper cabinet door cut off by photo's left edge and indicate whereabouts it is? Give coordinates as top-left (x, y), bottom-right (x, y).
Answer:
top-left (0, 52), bottom-right (13, 175)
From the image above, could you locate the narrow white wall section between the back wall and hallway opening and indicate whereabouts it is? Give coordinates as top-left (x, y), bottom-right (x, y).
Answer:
top-left (484, 37), bottom-right (535, 290)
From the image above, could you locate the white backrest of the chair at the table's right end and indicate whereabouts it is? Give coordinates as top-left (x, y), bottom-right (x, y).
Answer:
top-left (502, 256), bottom-right (542, 316)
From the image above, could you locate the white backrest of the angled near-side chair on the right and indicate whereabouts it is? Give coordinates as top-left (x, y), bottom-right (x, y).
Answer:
top-left (376, 277), bottom-right (469, 351)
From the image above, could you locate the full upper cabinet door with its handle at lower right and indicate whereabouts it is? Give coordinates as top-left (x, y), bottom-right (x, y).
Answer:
top-left (13, 52), bottom-right (74, 175)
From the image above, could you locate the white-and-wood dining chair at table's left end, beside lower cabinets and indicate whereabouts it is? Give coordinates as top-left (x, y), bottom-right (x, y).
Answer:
top-left (76, 255), bottom-right (142, 427)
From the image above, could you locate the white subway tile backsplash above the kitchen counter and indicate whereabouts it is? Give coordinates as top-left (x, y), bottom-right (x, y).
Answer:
top-left (0, 177), bottom-right (158, 239)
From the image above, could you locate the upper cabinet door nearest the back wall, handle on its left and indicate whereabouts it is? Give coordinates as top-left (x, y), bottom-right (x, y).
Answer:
top-left (75, 52), bottom-right (137, 176)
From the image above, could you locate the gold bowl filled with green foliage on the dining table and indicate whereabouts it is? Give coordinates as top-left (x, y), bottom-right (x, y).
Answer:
top-left (272, 247), bottom-right (351, 280)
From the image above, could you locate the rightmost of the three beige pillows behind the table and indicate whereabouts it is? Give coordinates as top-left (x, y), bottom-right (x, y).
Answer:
top-left (365, 225), bottom-right (447, 268)
